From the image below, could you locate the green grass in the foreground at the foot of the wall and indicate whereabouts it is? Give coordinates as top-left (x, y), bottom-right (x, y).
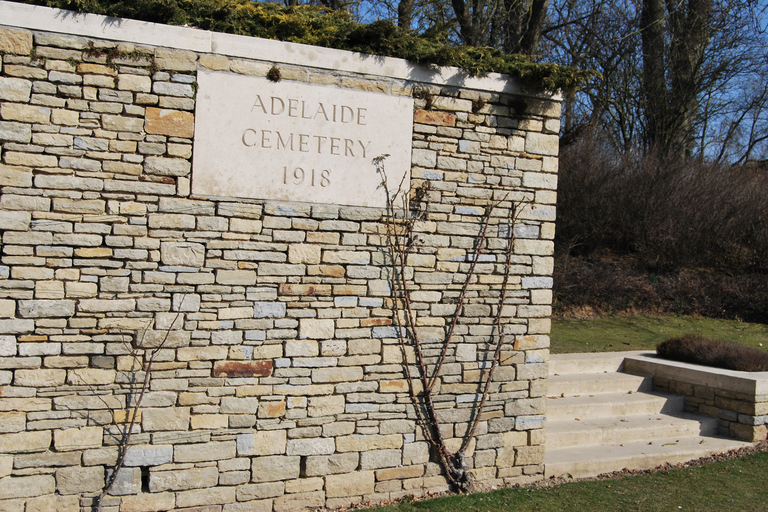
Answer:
top-left (376, 453), bottom-right (768, 512)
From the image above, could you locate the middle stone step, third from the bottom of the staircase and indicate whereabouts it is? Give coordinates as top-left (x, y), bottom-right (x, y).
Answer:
top-left (547, 393), bottom-right (685, 422)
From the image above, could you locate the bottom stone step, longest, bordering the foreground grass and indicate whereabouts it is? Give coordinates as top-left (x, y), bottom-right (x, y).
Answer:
top-left (544, 436), bottom-right (751, 478)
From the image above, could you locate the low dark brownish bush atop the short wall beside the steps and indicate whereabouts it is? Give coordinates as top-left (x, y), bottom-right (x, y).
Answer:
top-left (656, 334), bottom-right (768, 372)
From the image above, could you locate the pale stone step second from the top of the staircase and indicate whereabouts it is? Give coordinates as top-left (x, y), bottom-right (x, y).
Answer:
top-left (547, 373), bottom-right (653, 397)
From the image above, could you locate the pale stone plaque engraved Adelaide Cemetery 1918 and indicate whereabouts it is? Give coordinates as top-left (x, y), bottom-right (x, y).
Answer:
top-left (192, 70), bottom-right (413, 207)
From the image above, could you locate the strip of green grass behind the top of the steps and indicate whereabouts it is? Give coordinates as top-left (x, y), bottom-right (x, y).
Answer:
top-left (550, 316), bottom-right (768, 354)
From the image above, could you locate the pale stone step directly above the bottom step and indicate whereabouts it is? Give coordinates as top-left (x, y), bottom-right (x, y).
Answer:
top-left (547, 413), bottom-right (718, 449)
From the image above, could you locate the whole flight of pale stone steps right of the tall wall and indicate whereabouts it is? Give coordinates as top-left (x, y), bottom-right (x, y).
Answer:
top-left (544, 352), bottom-right (750, 478)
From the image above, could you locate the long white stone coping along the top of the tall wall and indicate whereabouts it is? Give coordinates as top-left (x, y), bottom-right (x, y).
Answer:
top-left (0, 0), bottom-right (562, 97)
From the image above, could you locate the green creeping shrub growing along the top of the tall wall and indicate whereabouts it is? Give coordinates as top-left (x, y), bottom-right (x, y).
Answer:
top-left (13, 0), bottom-right (592, 92)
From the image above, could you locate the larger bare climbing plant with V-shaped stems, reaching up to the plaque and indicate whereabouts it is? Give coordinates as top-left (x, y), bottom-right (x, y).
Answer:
top-left (373, 155), bottom-right (528, 492)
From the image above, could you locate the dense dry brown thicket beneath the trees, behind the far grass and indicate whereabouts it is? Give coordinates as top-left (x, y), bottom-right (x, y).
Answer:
top-left (555, 132), bottom-right (768, 323)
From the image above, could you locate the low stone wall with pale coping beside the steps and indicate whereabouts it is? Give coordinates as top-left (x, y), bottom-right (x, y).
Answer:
top-left (624, 356), bottom-right (768, 442)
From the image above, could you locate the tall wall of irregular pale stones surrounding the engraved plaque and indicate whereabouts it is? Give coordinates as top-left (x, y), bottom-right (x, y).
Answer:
top-left (0, 2), bottom-right (560, 512)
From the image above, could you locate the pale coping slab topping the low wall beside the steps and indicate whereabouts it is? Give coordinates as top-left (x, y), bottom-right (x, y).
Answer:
top-left (624, 352), bottom-right (768, 396)
